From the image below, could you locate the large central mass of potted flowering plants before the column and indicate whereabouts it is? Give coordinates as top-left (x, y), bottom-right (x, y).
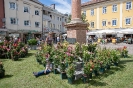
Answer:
top-left (36, 42), bottom-right (125, 83)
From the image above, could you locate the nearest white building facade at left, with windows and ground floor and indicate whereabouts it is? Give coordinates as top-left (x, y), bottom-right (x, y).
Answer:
top-left (4, 0), bottom-right (43, 40)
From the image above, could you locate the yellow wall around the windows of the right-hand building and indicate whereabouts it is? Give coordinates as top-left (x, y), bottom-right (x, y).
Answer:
top-left (82, 0), bottom-right (133, 30)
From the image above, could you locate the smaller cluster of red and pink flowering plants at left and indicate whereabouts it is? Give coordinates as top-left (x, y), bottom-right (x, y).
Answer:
top-left (0, 38), bottom-right (28, 60)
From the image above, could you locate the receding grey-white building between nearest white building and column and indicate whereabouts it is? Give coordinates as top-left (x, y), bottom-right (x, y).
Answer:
top-left (43, 5), bottom-right (68, 36)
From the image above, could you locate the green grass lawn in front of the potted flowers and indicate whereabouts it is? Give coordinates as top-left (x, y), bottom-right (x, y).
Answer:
top-left (0, 51), bottom-right (133, 88)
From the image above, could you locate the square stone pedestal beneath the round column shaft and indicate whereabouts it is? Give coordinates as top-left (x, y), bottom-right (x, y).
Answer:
top-left (65, 22), bottom-right (88, 44)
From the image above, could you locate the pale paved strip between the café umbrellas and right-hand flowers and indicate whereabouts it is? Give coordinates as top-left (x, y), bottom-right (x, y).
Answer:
top-left (99, 43), bottom-right (133, 55)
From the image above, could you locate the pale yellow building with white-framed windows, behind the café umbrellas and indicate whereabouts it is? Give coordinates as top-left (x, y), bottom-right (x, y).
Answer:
top-left (82, 0), bottom-right (133, 30)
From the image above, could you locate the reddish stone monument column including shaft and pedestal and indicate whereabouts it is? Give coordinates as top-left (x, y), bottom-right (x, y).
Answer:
top-left (65, 0), bottom-right (88, 44)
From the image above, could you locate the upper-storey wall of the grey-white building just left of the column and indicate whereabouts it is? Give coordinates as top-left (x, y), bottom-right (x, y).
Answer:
top-left (43, 7), bottom-right (67, 31)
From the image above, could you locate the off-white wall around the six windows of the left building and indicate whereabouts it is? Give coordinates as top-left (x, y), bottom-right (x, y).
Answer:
top-left (5, 0), bottom-right (42, 31)
